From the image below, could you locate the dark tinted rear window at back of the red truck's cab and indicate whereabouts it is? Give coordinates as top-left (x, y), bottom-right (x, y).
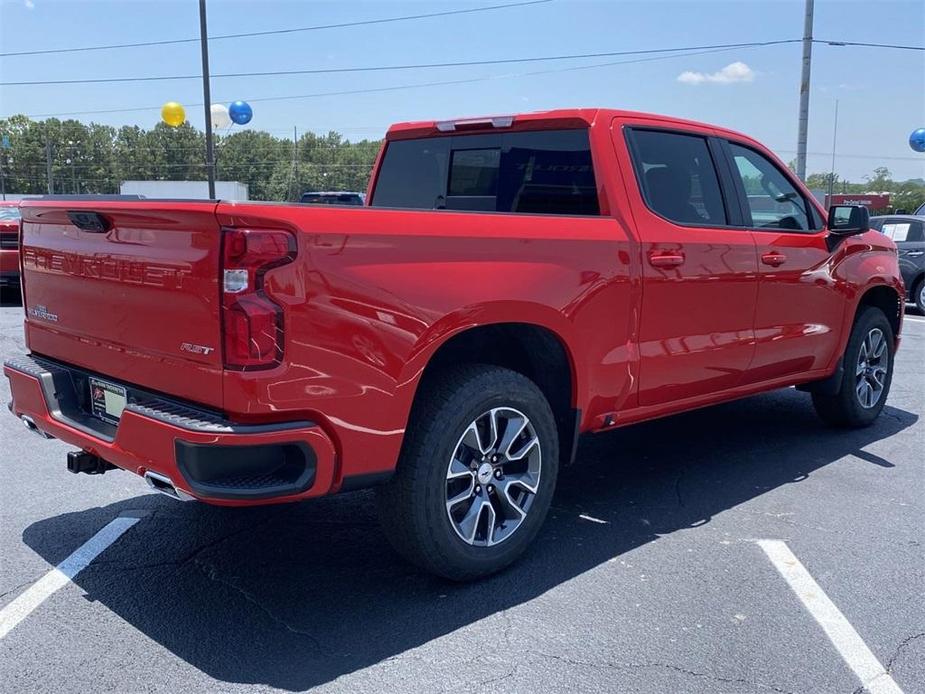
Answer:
top-left (372, 130), bottom-right (600, 215)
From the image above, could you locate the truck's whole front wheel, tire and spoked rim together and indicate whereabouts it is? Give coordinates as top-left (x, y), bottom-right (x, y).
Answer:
top-left (813, 306), bottom-right (894, 427)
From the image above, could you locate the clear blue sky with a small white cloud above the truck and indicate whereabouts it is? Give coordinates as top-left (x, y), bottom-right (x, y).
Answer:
top-left (0, 0), bottom-right (925, 180)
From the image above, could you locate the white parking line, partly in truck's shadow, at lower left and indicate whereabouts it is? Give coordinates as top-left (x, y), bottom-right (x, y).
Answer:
top-left (0, 516), bottom-right (141, 639)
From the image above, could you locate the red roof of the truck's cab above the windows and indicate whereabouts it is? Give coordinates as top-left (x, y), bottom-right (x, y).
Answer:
top-left (386, 108), bottom-right (752, 140)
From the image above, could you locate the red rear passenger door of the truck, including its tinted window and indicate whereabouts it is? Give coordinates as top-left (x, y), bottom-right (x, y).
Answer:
top-left (615, 121), bottom-right (758, 407)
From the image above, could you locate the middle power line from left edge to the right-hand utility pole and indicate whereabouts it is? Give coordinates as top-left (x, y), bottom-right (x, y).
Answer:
top-left (0, 39), bottom-right (800, 87)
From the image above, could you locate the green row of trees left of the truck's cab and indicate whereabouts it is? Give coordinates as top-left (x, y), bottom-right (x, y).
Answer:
top-left (0, 115), bottom-right (381, 200)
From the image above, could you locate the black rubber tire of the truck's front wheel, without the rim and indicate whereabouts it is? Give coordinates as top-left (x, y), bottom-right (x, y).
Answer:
top-left (813, 306), bottom-right (895, 428)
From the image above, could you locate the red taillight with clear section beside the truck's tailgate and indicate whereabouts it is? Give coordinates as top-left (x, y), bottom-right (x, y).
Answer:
top-left (222, 229), bottom-right (296, 370)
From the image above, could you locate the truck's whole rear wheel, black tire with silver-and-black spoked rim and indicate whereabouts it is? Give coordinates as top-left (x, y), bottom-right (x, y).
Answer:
top-left (377, 365), bottom-right (559, 580)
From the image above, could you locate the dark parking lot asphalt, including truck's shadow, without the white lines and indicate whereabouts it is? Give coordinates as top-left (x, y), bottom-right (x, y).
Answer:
top-left (0, 294), bottom-right (925, 694)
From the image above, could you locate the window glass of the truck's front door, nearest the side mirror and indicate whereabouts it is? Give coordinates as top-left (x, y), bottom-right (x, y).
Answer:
top-left (729, 143), bottom-right (814, 231)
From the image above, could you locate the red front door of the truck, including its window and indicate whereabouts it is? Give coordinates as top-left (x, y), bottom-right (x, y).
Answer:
top-left (724, 141), bottom-right (845, 383)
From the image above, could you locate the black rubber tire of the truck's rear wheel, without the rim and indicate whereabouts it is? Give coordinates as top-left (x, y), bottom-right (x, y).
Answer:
top-left (376, 364), bottom-right (559, 581)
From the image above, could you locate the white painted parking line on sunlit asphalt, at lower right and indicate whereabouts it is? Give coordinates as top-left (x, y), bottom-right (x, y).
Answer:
top-left (758, 540), bottom-right (902, 694)
